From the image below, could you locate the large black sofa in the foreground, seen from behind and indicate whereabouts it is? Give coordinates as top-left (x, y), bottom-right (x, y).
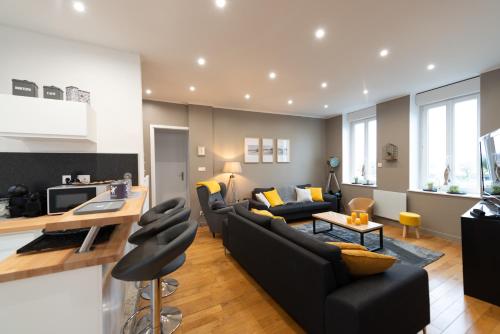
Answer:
top-left (223, 208), bottom-right (430, 334)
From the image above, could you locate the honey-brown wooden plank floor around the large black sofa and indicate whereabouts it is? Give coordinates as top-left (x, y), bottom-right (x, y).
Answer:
top-left (147, 225), bottom-right (500, 334)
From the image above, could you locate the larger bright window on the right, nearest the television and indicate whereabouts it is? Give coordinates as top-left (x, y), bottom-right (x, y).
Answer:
top-left (420, 94), bottom-right (479, 193)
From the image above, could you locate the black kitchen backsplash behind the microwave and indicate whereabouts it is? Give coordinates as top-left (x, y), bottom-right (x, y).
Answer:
top-left (0, 152), bottom-right (138, 195)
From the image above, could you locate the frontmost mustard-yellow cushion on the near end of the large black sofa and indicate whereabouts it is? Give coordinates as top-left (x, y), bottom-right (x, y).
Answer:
top-left (342, 249), bottom-right (396, 276)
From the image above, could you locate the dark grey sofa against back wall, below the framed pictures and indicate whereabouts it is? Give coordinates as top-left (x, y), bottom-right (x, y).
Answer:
top-left (249, 184), bottom-right (339, 221)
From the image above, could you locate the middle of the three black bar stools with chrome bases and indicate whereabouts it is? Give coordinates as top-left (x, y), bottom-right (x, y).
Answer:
top-left (128, 208), bottom-right (191, 300)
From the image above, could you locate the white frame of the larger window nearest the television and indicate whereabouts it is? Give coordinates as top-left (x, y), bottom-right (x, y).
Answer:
top-left (418, 93), bottom-right (481, 194)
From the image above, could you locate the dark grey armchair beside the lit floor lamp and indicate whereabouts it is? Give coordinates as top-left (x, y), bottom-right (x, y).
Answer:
top-left (196, 182), bottom-right (249, 238)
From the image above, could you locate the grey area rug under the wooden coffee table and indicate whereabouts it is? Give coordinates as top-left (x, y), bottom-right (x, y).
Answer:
top-left (293, 221), bottom-right (444, 268)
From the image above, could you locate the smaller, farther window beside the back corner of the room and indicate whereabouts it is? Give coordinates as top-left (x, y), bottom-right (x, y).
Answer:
top-left (350, 118), bottom-right (377, 184)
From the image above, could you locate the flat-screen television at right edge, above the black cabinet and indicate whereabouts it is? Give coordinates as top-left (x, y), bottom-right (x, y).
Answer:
top-left (479, 129), bottom-right (500, 201)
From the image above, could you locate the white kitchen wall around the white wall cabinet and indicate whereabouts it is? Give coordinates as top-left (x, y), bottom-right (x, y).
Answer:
top-left (0, 25), bottom-right (144, 179)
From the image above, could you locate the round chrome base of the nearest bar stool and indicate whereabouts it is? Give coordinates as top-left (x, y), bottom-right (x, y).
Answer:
top-left (122, 306), bottom-right (182, 334)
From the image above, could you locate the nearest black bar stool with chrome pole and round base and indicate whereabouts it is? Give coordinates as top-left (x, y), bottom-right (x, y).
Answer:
top-left (111, 220), bottom-right (198, 334)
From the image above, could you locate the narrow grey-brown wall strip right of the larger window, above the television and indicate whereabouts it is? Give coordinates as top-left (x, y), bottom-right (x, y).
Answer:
top-left (480, 69), bottom-right (500, 135)
